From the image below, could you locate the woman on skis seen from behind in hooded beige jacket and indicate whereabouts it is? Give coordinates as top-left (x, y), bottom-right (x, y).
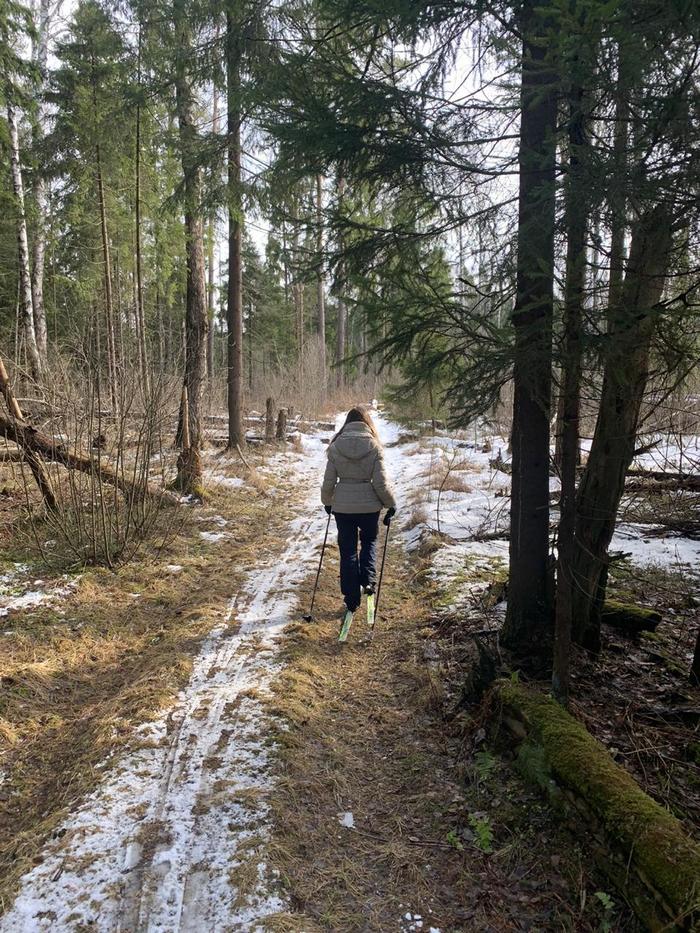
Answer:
top-left (321, 406), bottom-right (396, 640)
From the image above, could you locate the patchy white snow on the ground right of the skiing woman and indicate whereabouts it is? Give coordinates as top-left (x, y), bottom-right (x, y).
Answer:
top-left (377, 415), bottom-right (700, 608)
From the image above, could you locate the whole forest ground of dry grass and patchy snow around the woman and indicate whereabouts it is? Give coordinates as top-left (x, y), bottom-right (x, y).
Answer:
top-left (0, 410), bottom-right (700, 933)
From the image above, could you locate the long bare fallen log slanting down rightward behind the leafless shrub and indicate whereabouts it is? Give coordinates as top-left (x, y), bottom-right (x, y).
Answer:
top-left (0, 414), bottom-right (179, 504)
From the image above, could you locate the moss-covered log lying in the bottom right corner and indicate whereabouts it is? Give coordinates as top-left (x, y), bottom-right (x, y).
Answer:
top-left (494, 682), bottom-right (700, 930)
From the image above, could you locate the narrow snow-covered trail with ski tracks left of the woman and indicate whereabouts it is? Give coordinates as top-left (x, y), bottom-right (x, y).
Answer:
top-left (0, 430), bottom-right (334, 933)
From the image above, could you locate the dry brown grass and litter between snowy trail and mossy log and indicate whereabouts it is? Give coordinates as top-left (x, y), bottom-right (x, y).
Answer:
top-left (269, 548), bottom-right (631, 933)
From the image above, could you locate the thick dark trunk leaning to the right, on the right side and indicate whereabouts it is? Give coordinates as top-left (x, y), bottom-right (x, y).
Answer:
top-left (573, 205), bottom-right (671, 651)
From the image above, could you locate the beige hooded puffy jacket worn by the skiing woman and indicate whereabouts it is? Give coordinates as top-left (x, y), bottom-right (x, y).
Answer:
top-left (321, 421), bottom-right (396, 515)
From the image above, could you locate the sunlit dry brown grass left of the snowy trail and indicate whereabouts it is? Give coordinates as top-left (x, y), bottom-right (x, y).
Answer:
top-left (0, 456), bottom-right (293, 908)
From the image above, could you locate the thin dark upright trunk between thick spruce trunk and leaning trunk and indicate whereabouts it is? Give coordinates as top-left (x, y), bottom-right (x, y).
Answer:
top-left (552, 80), bottom-right (590, 705)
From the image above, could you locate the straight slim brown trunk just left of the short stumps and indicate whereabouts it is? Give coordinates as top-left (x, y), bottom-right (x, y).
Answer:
top-left (226, 11), bottom-right (245, 450)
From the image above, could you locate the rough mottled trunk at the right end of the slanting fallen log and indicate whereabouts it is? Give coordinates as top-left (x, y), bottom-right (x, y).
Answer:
top-left (173, 0), bottom-right (209, 474)
